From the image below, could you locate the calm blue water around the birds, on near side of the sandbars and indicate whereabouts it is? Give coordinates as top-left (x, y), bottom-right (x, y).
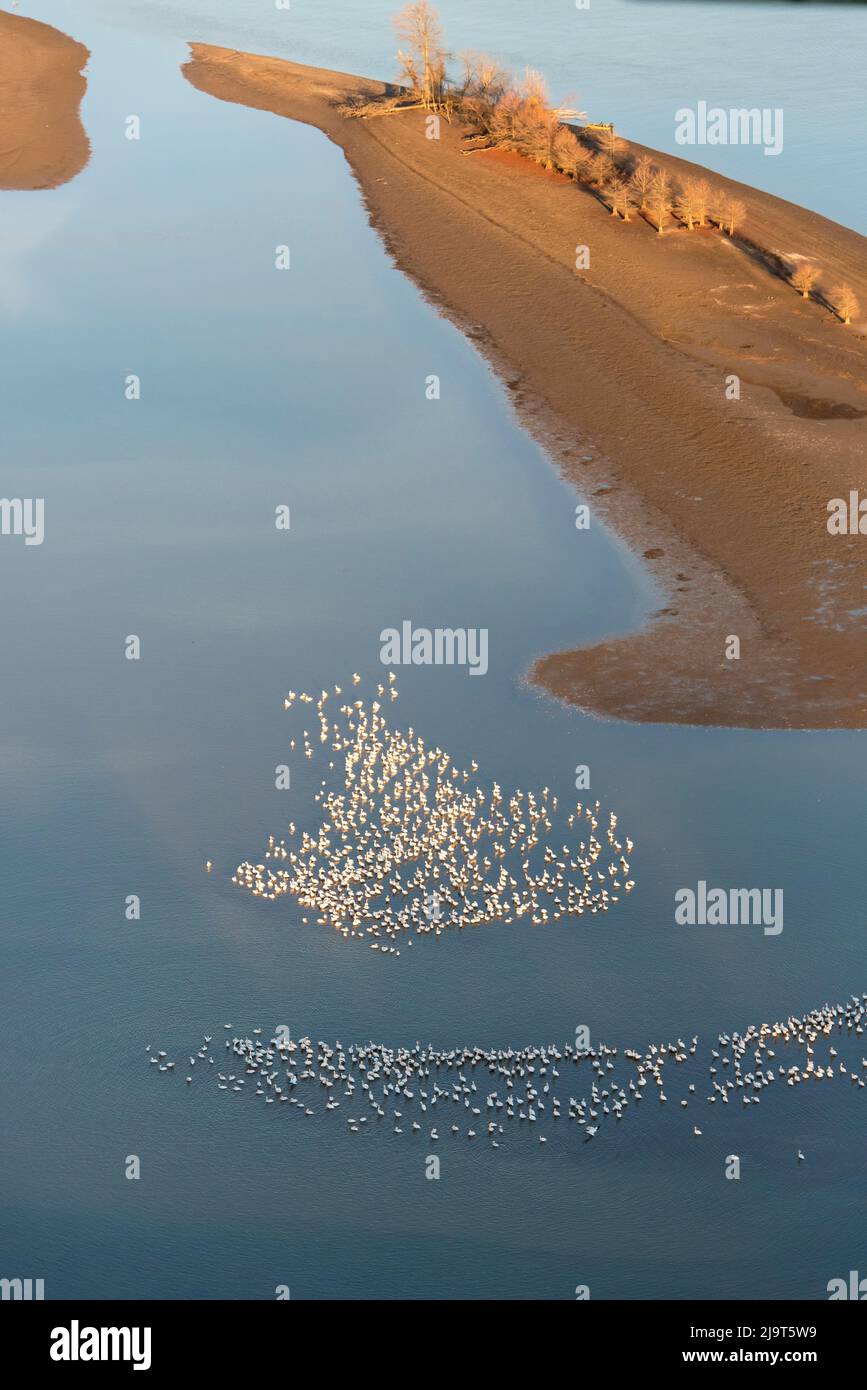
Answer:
top-left (0, 0), bottom-right (867, 1298)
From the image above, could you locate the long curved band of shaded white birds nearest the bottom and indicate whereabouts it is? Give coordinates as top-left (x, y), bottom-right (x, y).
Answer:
top-left (147, 994), bottom-right (867, 1162)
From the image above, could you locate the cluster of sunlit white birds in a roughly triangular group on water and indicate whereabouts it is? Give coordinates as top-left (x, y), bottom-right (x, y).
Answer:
top-left (230, 673), bottom-right (634, 955)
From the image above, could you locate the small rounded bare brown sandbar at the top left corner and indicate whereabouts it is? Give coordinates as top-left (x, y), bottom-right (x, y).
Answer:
top-left (0, 10), bottom-right (90, 189)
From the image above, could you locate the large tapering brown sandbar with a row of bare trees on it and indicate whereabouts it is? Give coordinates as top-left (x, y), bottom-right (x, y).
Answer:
top-left (183, 44), bottom-right (867, 728)
